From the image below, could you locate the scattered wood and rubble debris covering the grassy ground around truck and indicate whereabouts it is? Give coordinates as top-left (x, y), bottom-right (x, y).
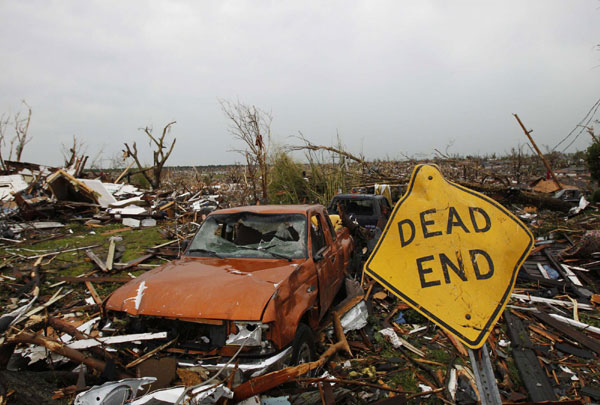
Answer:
top-left (0, 157), bottom-right (600, 404)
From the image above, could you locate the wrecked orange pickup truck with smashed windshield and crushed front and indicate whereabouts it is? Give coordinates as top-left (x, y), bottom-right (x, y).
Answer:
top-left (103, 205), bottom-right (353, 377)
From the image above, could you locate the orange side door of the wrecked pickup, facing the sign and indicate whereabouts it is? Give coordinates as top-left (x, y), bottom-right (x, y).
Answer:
top-left (310, 213), bottom-right (342, 318)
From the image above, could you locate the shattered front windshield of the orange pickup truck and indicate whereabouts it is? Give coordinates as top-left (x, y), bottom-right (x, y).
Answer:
top-left (186, 212), bottom-right (307, 259)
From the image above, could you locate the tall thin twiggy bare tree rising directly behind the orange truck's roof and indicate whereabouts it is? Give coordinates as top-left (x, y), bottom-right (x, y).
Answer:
top-left (219, 100), bottom-right (273, 202)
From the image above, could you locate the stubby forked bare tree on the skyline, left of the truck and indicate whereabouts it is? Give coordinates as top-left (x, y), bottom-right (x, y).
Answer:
top-left (123, 121), bottom-right (177, 190)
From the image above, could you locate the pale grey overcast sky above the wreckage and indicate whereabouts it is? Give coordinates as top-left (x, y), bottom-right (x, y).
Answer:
top-left (0, 0), bottom-right (600, 166)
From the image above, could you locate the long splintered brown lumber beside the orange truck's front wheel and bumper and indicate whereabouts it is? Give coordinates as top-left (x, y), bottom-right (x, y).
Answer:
top-left (233, 314), bottom-right (352, 402)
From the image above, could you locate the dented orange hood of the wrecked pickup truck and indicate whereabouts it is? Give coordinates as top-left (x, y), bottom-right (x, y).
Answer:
top-left (105, 257), bottom-right (304, 321)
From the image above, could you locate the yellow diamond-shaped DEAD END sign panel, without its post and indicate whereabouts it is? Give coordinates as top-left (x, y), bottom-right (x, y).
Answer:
top-left (365, 165), bottom-right (533, 349)
